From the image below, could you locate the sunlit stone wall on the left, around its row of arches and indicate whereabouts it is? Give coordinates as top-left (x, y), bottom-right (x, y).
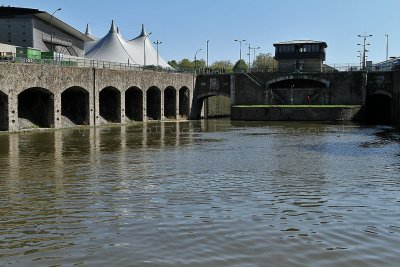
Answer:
top-left (0, 63), bottom-right (194, 131)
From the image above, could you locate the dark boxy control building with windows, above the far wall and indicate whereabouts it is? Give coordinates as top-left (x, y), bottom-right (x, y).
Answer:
top-left (274, 40), bottom-right (328, 72)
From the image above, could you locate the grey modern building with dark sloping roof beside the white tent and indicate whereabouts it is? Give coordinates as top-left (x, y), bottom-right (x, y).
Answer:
top-left (0, 6), bottom-right (92, 57)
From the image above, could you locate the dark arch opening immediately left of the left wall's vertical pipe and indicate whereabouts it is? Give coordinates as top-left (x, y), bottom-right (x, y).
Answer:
top-left (61, 87), bottom-right (89, 126)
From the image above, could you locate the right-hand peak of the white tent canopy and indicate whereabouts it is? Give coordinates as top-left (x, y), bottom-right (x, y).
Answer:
top-left (128, 24), bottom-right (171, 68)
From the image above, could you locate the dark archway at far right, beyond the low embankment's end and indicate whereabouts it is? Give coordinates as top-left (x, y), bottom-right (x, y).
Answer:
top-left (366, 94), bottom-right (392, 124)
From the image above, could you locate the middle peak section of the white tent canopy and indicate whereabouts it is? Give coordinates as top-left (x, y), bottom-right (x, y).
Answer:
top-left (85, 21), bottom-right (138, 64)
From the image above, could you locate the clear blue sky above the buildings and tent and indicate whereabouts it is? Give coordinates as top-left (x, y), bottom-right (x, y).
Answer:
top-left (0, 0), bottom-right (400, 65)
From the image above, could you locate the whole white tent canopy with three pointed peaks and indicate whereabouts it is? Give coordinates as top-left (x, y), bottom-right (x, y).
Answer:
top-left (85, 21), bottom-right (171, 68)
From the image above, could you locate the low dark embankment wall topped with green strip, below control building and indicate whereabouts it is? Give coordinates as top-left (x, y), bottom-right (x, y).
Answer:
top-left (231, 105), bottom-right (363, 121)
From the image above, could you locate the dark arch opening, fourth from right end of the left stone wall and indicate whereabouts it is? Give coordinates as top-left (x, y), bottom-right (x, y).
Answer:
top-left (125, 87), bottom-right (143, 121)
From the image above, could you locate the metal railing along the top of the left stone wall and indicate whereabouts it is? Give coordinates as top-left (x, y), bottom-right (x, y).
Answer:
top-left (0, 52), bottom-right (194, 74)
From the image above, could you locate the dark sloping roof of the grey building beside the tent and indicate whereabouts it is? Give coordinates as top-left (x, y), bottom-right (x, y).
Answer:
top-left (0, 6), bottom-right (92, 42)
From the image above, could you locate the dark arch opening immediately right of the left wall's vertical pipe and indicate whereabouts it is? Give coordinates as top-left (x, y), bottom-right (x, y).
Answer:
top-left (99, 87), bottom-right (121, 123)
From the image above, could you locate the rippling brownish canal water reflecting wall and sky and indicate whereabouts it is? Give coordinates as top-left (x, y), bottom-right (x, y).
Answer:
top-left (0, 120), bottom-right (400, 267)
